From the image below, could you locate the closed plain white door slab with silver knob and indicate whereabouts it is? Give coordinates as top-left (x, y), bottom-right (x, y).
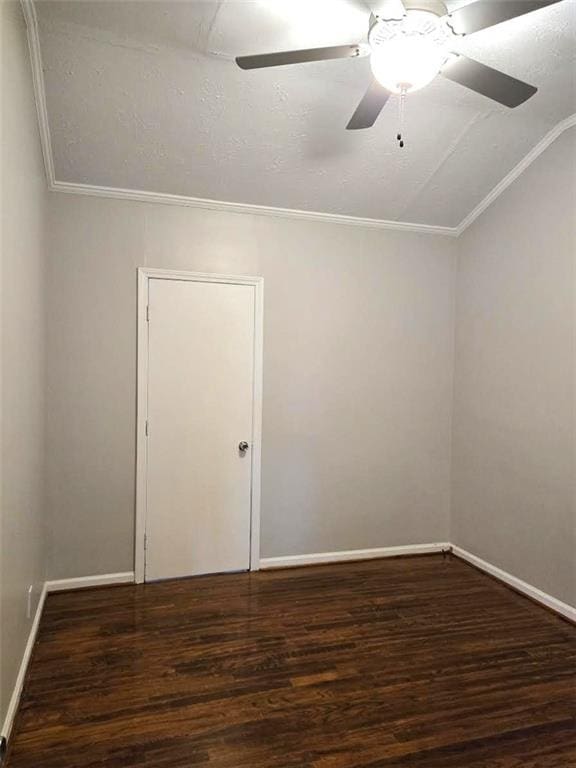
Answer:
top-left (145, 279), bottom-right (255, 581)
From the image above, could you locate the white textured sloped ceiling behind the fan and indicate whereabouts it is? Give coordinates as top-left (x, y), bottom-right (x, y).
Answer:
top-left (36, 0), bottom-right (576, 227)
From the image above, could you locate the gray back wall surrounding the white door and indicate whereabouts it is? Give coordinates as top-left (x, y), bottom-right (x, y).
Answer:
top-left (47, 193), bottom-right (456, 578)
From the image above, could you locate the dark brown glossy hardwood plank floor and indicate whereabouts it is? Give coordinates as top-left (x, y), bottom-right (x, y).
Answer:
top-left (8, 556), bottom-right (576, 768)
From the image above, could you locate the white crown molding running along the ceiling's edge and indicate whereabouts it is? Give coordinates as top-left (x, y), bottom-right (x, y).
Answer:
top-left (20, 0), bottom-right (576, 237)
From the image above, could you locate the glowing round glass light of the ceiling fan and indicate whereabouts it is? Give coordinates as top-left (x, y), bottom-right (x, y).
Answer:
top-left (368, 10), bottom-right (451, 93)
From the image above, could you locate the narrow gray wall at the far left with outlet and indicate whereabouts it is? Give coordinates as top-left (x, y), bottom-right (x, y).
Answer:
top-left (0, 2), bottom-right (47, 724)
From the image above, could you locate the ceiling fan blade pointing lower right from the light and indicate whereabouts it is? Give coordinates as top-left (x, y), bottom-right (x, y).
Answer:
top-left (441, 56), bottom-right (538, 107)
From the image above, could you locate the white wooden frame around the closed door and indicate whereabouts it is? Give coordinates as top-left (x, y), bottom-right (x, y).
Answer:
top-left (134, 267), bottom-right (264, 584)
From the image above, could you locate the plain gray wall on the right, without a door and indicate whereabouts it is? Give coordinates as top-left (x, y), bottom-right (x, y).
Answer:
top-left (452, 129), bottom-right (576, 605)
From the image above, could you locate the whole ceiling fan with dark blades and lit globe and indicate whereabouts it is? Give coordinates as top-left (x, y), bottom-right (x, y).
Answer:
top-left (236, 0), bottom-right (560, 130)
